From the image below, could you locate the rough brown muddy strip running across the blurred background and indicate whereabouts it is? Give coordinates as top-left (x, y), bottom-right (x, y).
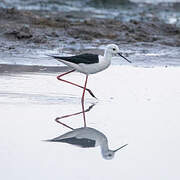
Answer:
top-left (0, 8), bottom-right (180, 48)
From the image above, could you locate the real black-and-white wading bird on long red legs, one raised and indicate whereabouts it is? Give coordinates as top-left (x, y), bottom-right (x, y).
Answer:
top-left (48, 44), bottom-right (131, 126)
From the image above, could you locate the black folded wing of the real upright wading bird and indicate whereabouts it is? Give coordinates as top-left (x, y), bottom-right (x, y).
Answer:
top-left (50, 54), bottom-right (99, 64)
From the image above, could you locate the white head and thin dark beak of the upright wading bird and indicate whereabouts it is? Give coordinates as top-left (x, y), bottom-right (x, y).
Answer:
top-left (105, 44), bottom-right (131, 63)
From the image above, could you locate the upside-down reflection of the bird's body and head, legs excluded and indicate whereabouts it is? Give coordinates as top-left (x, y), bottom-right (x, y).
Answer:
top-left (45, 127), bottom-right (128, 160)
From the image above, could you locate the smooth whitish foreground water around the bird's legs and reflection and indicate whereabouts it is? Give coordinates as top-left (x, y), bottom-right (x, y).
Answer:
top-left (0, 65), bottom-right (180, 180)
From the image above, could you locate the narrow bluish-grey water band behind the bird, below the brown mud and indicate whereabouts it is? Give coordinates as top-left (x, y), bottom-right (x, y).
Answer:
top-left (0, 42), bottom-right (180, 67)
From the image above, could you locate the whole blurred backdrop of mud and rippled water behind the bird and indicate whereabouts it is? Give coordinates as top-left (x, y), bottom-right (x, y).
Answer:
top-left (0, 0), bottom-right (180, 69)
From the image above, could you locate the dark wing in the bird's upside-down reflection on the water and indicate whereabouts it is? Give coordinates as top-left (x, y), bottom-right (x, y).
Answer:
top-left (48, 137), bottom-right (96, 148)
